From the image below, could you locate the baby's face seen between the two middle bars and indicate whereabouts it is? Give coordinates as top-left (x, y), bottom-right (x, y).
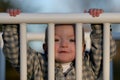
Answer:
top-left (55, 25), bottom-right (75, 63)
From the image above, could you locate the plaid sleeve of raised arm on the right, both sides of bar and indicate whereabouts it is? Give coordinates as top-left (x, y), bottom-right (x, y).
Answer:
top-left (90, 24), bottom-right (116, 76)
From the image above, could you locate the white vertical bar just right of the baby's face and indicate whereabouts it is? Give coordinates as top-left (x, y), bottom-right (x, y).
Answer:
top-left (76, 23), bottom-right (82, 80)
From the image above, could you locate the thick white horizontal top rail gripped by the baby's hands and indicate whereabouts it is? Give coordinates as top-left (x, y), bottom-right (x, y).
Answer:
top-left (0, 13), bottom-right (120, 24)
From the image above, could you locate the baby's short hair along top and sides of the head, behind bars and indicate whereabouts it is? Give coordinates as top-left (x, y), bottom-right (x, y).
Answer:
top-left (45, 24), bottom-right (85, 44)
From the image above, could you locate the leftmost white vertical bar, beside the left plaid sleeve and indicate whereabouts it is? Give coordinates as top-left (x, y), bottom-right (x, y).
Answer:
top-left (20, 23), bottom-right (27, 80)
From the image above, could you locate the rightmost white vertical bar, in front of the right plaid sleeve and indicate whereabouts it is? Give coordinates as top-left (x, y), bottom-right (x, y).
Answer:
top-left (103, 23), bottom-right (110, 80)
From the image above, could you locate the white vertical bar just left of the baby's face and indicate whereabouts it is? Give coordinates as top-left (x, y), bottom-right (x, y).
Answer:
top-left (48, 23), bottom-right (55, 80)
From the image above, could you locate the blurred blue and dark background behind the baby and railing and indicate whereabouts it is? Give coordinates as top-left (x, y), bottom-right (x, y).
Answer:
top-left (0, 0), bottom-right (120, 80)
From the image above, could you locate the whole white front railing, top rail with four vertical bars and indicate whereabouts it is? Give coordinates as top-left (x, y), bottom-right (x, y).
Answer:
top-left (0, 13), bottom-right (120, 80)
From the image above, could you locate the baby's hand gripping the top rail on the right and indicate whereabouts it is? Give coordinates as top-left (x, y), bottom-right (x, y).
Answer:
top-left (84, 9), bottom-right (104, 17)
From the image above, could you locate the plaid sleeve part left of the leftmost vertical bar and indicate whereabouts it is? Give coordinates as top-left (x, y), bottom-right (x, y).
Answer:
top-left (2, 25), bottom-right (20, 71)
